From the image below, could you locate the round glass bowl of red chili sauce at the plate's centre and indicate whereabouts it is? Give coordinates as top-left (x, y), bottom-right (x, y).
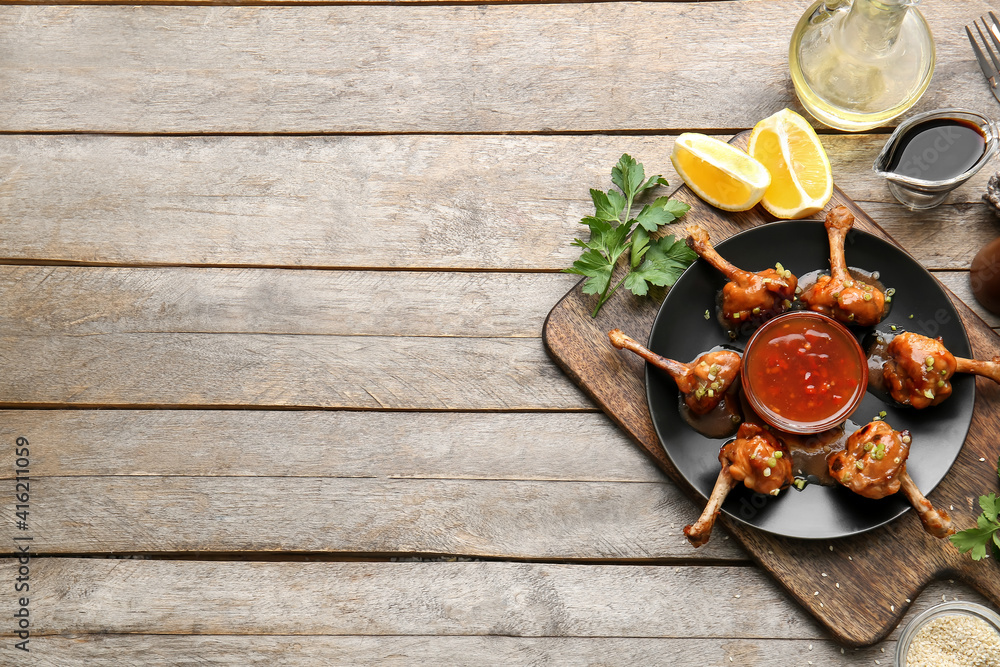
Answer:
top-left (743, 312), bottom-right (868, 433)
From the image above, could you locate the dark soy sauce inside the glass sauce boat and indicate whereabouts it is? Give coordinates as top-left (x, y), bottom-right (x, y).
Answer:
top-left (886, 118), bottom-right (986, 181)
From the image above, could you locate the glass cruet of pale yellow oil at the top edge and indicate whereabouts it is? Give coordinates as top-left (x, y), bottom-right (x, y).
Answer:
top-left (788, 0), bottom-right (935, 131)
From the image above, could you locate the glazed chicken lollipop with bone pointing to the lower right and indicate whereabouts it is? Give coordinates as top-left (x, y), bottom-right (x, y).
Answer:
top-left (829, 421), bottom-right (955, 537)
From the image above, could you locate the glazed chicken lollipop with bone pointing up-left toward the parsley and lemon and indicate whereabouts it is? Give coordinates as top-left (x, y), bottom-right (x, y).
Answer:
top-left (686, 225), bottom-right (798, 328)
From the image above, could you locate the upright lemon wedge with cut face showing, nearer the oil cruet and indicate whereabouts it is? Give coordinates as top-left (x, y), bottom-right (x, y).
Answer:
top-left (747, 109), bottom-right (833, 218)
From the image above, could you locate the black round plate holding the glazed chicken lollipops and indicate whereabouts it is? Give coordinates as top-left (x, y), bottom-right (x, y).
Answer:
top-left (646, 220), bottom-right (975, 539)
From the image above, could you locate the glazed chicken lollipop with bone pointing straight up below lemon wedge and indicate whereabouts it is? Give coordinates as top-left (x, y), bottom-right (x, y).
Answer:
top-left (799, 206), bottom-right (885, 327)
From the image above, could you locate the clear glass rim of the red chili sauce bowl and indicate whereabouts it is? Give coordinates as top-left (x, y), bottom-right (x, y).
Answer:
top-left (740, 310), bottom-right (868, 434)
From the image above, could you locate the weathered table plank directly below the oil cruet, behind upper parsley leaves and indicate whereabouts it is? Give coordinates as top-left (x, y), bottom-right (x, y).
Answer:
top-left (0, 136), bottom-right (1000, 271)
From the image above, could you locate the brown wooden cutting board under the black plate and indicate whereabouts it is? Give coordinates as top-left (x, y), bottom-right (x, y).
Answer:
top-left (543, 133), bottom-right (1000, 646)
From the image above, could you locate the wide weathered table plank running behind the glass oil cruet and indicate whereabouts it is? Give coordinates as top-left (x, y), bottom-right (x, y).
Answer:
top-left (0, 0), bottom-right (996, 133)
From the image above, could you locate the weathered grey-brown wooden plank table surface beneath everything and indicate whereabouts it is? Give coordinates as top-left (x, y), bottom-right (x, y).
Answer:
top-left (0, 0), bottom-right (1000, 666)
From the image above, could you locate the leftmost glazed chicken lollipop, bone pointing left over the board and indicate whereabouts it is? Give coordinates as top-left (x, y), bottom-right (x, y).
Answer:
top-left (608, 329), bottom-right (741, 415)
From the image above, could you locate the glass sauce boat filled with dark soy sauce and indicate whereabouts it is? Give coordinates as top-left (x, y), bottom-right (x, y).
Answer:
top-left (874, 109), bottom-right (998, 209)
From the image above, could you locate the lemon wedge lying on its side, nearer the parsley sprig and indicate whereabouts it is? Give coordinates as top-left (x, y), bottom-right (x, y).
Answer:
top-left (670, 132), bottom-right (771, 211)
